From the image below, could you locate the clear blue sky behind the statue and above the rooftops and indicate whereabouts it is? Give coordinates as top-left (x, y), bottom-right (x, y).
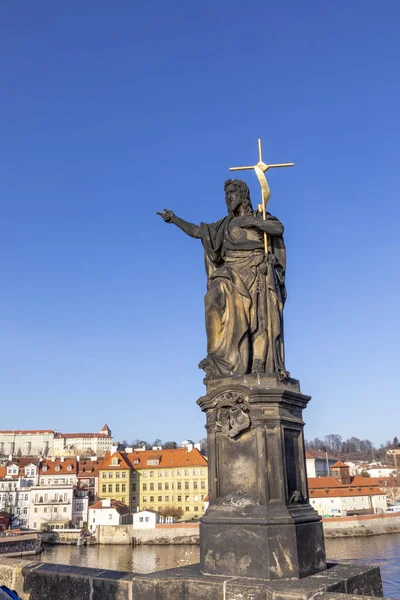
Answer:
top-left (0, 0), bottom-right (400, 443)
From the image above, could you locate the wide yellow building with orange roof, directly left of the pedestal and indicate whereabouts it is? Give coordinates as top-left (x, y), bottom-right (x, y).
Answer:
top-left (126, 446), bottom-right (208, 520)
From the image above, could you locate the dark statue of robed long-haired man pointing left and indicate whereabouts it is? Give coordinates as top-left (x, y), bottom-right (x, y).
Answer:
top-left (157, 176), bottom-right (289, 379)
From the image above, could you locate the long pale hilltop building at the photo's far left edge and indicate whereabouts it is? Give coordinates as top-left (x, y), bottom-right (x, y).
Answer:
top-left (0, 429), bottom-right (55, 456)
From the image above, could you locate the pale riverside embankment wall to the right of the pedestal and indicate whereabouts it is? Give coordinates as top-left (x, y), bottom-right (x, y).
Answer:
top-left (322, 513), bottom-right (400, 538)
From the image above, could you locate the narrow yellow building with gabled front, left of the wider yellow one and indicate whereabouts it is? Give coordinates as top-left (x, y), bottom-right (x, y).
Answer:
top-left (98, 452), bottom-right (132, 506)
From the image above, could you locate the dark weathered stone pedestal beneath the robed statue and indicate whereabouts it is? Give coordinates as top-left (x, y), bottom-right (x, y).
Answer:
top-left (198, 374), bottom-right (326, 580)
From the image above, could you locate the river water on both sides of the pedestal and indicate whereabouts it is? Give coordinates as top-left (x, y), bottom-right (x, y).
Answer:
top-left (38, 533), bottom-right (400, 598)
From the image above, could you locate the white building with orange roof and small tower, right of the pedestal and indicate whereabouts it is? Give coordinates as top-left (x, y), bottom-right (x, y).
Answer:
top-left (308, 461), bottom-right (387, 517)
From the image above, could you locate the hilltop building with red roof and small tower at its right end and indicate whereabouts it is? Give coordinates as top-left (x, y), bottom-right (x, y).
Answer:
top-left (53, 425), bottom-right (113, 456)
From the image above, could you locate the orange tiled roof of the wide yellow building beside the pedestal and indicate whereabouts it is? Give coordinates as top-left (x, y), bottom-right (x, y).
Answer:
top-left (126, 448), bottom-right (208, 469)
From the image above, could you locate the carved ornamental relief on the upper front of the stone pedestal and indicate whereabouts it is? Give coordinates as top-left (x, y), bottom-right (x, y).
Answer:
top-left (215, 391), bottom-right (250, 438)
